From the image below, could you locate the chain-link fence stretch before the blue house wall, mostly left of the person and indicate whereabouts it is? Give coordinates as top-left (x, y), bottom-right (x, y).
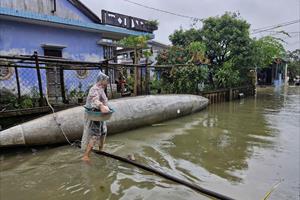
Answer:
top-left (0, 54), bottom-right (122, 112)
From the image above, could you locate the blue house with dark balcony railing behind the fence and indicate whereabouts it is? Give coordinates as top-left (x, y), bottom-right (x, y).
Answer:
top-left (0, 0), bottom-right (155, 103)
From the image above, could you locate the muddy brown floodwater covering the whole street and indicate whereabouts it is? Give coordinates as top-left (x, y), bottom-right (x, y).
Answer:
top-left (0, 87), bottom-right (300, 200)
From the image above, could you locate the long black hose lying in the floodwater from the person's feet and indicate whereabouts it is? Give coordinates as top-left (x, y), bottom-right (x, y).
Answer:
top-left (93, 151), bottom-right (233, 200)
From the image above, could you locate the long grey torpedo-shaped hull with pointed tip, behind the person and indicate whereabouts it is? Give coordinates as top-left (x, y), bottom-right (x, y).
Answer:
top-left (0, 95), bottom-right (208, 147)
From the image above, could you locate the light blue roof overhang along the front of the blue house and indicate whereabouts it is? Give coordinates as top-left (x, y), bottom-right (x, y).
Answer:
top-left (0, 7), bottom-right (154, 40)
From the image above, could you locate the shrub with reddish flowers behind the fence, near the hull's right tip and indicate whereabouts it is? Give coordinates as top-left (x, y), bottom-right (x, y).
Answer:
top-left (157, 41), bottom-right (208, 93)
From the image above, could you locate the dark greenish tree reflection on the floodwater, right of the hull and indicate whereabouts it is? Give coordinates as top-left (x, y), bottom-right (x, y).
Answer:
top-left (168, 101), bottom-right (274, 182)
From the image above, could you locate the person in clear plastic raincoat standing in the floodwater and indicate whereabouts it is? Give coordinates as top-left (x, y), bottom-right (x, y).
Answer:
top-left (81, 72), bottom-right (109, 161)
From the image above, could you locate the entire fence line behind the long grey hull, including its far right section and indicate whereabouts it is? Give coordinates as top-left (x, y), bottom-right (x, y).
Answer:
top-left (0, 53), bottom-right (253, 118)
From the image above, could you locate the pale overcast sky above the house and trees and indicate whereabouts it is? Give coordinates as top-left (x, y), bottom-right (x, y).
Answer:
top-left (81, 0), bottom-right (300, 50)
